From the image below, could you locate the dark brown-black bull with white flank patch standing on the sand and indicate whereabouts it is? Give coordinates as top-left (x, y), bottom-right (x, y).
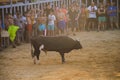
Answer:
top-left (31, 36), bottom-right (82, 64)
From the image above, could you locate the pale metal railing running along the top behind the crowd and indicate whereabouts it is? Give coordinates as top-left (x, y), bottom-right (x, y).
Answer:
top-left (0, 0), bottom-right (120, 23)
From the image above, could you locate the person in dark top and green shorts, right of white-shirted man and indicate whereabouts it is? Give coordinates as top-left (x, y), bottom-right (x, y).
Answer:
top-left (98, 4), bottom-right (106, 31)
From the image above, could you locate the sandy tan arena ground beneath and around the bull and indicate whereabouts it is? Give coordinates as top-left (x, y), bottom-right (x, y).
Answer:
top-left (0, 30), bottom-right (120, 80)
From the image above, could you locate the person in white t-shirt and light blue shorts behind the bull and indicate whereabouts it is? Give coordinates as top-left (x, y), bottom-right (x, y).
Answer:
top-left (48, 11), bottom-right (56, 36)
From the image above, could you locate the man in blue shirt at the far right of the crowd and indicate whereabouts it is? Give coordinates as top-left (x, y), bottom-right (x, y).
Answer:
top-left (107, 2), bottom-right (119, 29)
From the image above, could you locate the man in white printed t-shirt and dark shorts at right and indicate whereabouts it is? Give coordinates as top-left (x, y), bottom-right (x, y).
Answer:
top-left (87, 2), bottom-right (97, 30)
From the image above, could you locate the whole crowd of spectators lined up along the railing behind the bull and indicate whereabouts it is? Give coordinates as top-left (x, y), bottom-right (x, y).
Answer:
top-left (0, 2), bottom-right (120, 50)
